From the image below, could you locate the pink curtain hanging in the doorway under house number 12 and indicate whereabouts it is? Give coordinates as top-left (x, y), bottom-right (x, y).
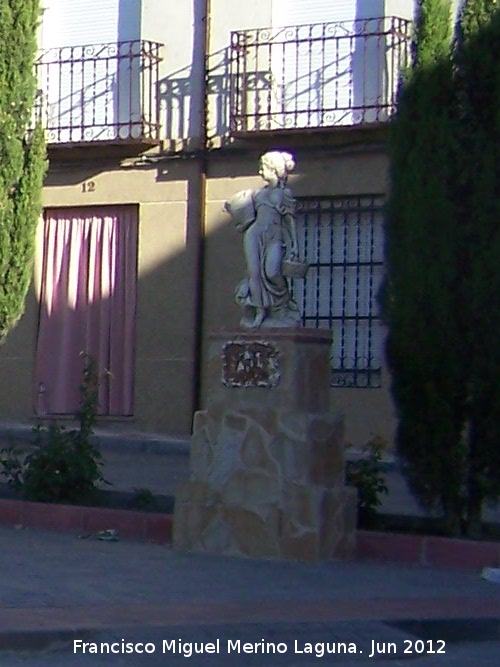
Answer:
top-left (35, 206), bottom-right (137, 416)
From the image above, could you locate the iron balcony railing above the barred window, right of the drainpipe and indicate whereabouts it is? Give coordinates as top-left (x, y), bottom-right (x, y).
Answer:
top-left (230, 17), bottom-right (410, 133)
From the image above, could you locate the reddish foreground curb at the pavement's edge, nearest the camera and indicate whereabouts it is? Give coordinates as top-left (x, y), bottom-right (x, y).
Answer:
top-left (0, 597), bottom-right (500, 662)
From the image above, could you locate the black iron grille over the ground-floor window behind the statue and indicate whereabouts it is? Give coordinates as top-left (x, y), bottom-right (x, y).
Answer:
top-left (292, 195), bottom-right (384, 388)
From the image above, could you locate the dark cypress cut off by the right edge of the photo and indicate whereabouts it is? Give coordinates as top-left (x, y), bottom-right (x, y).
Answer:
top-left (455, 0), bottom-right (500, 536)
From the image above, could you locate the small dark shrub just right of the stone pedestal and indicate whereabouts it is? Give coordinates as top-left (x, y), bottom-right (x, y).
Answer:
top-left (345, 436), bottom-right (389, 526)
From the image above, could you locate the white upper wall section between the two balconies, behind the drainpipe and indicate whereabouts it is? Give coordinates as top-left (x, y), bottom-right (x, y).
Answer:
top-left (153, 0), bottom-right (272, 150)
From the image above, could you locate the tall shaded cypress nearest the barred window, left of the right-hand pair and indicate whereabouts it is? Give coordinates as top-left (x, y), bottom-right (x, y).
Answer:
top-left (382, 0), bottom-right (466, 534)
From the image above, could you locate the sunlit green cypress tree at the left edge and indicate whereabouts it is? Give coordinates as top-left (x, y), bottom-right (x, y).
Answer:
top-left (0, 0), bottom-right (46, 342)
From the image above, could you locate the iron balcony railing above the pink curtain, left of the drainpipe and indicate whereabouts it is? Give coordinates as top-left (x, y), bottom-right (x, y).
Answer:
top-left (35, 40), bottom-right (161, 144)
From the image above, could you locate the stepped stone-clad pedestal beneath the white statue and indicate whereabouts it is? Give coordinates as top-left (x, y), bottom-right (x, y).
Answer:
top-left (174, 329), bottom-right (356, 560)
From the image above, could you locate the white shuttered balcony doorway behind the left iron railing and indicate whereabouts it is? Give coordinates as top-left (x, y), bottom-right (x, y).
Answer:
top-left (41, 0), bottom-right (141, 143)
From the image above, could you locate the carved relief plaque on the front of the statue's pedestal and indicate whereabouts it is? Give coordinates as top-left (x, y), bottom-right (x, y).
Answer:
top-left (222, 341), bottom-right (280, 387)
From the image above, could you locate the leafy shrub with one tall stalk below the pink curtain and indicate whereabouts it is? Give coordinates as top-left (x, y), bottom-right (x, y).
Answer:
top-left (0, 355), bottom-right (106, 503)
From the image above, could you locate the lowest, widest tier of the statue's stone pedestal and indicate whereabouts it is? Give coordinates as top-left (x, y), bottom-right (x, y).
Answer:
top-left (174, 482), bottom-right (356, 561)
